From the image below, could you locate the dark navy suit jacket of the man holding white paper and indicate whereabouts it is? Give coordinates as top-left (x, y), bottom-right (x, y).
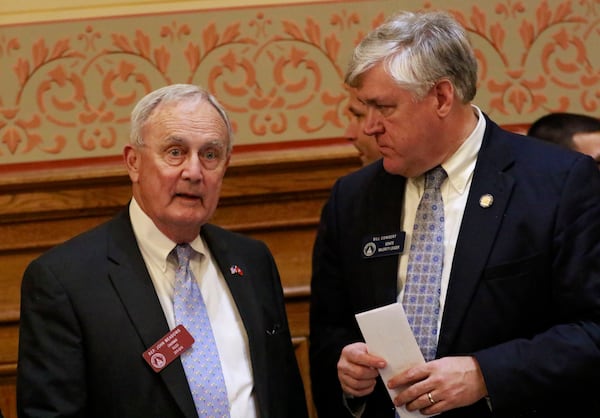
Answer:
top-left (310, 119), bottom-right (600, 418)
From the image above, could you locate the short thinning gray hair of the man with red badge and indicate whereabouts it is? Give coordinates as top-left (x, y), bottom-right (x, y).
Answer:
top-left (129, 84), bottom-right (233, 154)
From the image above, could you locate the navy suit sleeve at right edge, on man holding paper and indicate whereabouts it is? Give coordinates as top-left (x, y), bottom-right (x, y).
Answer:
top-left (475, 157), bottom-right (600, 411)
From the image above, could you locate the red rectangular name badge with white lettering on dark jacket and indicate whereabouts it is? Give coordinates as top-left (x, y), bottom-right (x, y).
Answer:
top-left (142, 325), bottom-right (194, 373)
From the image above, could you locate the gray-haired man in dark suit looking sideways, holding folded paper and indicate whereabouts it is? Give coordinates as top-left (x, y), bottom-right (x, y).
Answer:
top-left (310, 12), bottom-right (600, 418)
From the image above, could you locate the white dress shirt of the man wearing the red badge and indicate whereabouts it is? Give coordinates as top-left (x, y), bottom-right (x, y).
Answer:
top-left (129, 198), bottom-right (258, 418)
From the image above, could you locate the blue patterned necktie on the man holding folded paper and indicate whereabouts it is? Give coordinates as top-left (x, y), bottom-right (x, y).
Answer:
top-left (402, 166), bottom-right (447, 361)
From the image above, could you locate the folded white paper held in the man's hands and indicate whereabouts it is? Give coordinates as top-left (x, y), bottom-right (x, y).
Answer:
top-left (355, 303), bottom-right (431, 418)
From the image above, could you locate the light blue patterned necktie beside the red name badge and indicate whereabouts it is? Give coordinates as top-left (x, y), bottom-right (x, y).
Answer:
top-left (173, 244), bottom-right (229, 418)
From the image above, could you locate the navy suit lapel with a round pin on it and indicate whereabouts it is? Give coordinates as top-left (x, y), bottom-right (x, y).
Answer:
top-left (437, 119), bottom-right (514, 357)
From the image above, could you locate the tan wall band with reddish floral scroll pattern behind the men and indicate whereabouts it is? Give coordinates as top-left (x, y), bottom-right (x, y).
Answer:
top-left (0, 0), bottom-right (600, 165)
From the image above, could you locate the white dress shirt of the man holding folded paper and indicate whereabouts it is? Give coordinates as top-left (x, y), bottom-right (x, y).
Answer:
top-left (398, 106), bottom-right (486, 336)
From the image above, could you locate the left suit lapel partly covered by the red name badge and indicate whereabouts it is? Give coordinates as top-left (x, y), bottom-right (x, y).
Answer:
top-left (107, 210), bottom-right (197, 418)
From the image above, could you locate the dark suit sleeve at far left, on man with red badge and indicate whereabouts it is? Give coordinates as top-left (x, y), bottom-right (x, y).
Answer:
top-left (17, 261), bottom-right (86, 418)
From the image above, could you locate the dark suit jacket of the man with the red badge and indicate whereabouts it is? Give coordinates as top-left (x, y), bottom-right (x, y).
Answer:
top-left (17, 210), bottom-right (307, 418)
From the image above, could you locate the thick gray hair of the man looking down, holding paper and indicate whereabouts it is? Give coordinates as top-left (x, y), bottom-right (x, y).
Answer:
top-left (345, 11), bottom-right (477, 103)
